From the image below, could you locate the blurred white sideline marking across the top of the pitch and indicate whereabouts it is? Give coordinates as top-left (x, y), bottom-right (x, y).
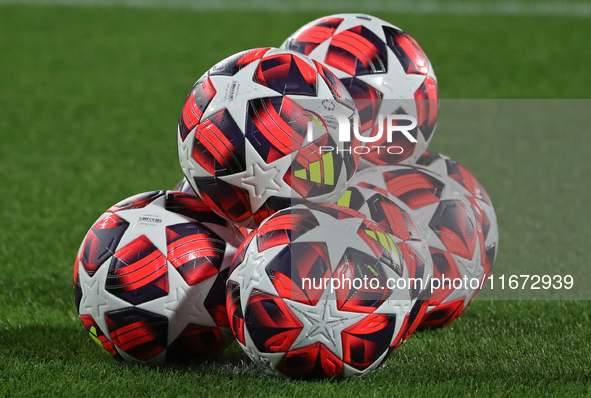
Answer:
top-left (0, 0), bottom-right (591, 17)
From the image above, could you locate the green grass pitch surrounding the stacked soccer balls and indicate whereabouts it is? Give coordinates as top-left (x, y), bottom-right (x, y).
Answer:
top-left (0, 5), bottom-right (591, 397)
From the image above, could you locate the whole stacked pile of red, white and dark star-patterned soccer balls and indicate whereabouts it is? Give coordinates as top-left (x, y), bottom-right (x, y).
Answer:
top-left (74, 14), bottom-right (498, 378)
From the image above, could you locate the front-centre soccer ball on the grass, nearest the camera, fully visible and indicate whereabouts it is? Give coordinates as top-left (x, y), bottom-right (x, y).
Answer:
top-left (226, 204), bottom-right (416, 379)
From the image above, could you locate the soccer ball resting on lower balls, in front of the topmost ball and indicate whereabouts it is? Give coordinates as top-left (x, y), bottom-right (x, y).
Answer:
top-left (178, 48), bottom-right (359, 228)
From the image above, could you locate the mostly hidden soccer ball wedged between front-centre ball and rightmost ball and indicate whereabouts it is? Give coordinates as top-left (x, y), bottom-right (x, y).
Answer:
top-left (337, 182), bottom-right (433, 342)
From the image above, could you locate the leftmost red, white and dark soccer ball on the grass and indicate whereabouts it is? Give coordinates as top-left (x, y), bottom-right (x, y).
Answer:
top-left (74, 191), bottom-right (235, 365)
